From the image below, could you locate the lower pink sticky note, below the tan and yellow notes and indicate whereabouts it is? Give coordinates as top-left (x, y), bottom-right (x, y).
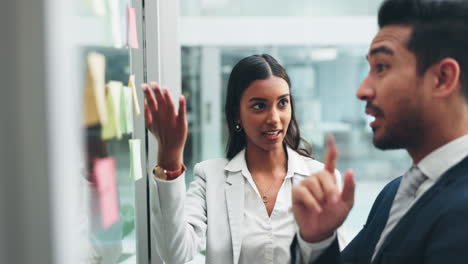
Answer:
top-left (94, 157), bottom-right (119, 229)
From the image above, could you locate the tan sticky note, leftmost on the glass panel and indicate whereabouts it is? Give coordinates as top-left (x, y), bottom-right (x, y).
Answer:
top-left (84, 52), bottom-right (107, 126)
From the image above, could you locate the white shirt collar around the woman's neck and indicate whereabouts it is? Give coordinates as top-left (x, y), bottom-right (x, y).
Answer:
top-left (224, 147), bottom-right (310, 178)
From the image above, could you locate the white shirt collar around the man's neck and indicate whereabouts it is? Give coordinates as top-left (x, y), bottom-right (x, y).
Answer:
top-left (417, 134), bottom-right (468, 181)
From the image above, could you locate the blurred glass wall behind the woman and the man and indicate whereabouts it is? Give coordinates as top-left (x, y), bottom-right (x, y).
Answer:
top-left (181, 0), bottom-right (410, 244)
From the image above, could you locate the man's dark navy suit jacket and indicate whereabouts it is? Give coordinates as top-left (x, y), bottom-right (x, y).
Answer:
top-left (291, 157), bottom-right (468, 264)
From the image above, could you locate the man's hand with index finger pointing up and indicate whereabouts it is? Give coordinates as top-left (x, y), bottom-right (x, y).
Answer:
top-left (292, 136), bottom-right (354, 243)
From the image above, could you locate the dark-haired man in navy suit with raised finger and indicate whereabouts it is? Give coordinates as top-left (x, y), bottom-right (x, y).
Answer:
top-left (291, 0), bottom-right (468, 264)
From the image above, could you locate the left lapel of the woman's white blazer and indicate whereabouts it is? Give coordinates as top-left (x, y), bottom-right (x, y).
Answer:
top-left (225, 171), bottom-right (244, 264)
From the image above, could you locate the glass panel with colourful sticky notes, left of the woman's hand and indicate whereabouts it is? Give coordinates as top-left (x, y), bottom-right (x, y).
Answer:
top-left (75, 0), bottom-right (146, 264)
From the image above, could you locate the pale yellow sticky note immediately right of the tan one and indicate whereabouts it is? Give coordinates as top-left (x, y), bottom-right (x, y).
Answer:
top-left (101, 81), bottom-right (122, 140)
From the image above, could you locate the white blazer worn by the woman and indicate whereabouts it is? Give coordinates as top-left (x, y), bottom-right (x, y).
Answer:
top-left (150, 148), bottom-right (341, 264)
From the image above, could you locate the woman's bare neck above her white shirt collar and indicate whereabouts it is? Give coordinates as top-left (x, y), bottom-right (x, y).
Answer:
top-left (245, 143), bottom-right (288, 176)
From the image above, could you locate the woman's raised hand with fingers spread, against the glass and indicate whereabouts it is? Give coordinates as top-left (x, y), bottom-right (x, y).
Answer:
top-left (142, 82), bottom-right (187, 171)
